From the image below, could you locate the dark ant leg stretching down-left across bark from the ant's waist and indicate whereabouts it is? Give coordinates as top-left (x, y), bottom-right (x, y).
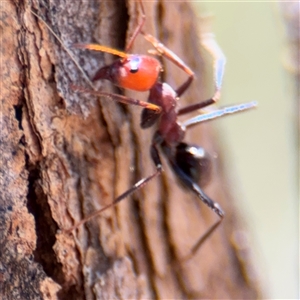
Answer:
top-left (64, 143), bottom-right (162, 233)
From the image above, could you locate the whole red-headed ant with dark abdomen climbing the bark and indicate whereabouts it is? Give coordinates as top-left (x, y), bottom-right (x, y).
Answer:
top-left (66, 0), bottom-right (256, 258)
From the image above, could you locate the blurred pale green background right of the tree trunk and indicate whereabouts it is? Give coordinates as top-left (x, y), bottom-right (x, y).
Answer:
top-left (193, 1), bottom-right (300, 299)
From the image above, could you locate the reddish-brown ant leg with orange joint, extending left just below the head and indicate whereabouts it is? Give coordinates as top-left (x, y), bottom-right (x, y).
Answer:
top-left (71, 85), bottom-right (161, 114)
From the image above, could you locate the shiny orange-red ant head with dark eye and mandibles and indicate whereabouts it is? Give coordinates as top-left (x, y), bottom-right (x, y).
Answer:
top-left (93, 55), bottom-right (162, 92)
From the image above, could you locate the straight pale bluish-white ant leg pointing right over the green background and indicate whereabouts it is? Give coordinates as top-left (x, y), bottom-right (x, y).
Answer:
top-left (182, 101), bottom-right (257, 128)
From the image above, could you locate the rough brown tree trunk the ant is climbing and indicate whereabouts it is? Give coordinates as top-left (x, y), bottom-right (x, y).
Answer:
top-left (0, 0), bottom-right (258, 299)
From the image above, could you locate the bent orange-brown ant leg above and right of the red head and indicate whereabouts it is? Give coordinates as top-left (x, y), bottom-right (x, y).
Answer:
top-left (142, 32), bottom-right (195, 97)
